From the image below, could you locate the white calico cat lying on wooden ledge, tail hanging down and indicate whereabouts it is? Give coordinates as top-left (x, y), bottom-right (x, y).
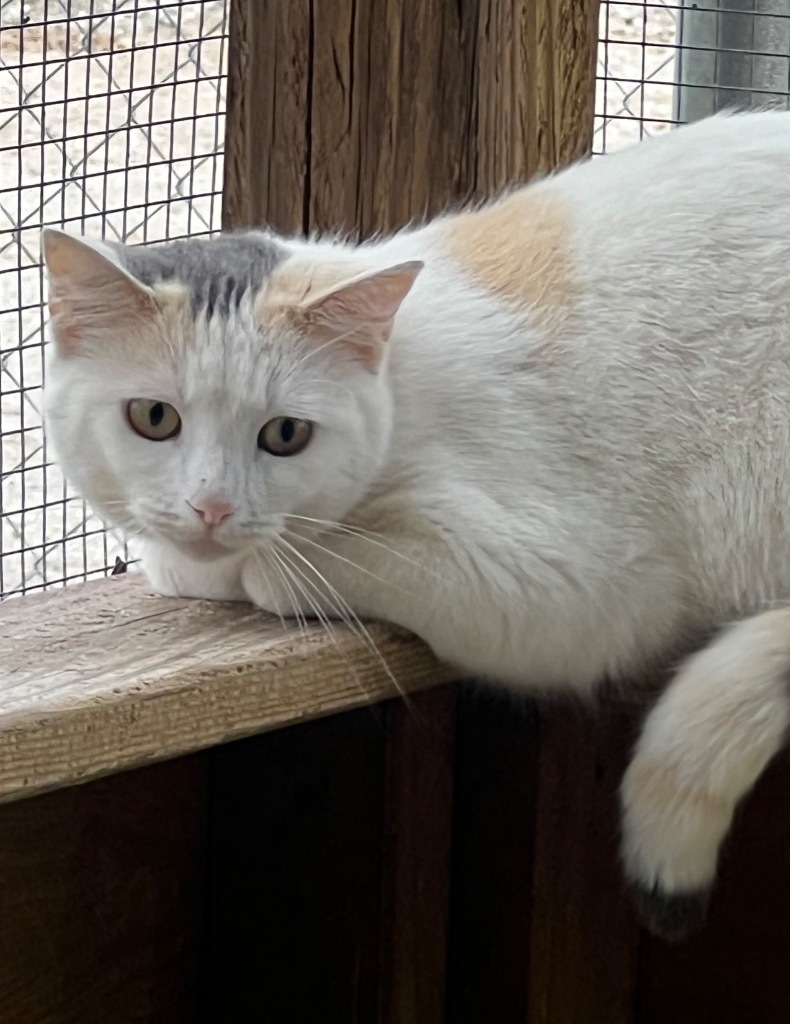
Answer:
top-left (43, 113), bottom-right (790, 937)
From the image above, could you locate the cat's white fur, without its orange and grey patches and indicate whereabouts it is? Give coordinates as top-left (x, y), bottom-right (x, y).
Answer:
top-left (41, 113), bottom-right (790, 921)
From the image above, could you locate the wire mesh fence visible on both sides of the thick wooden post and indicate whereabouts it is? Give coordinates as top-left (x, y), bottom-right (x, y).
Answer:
top-left (0, 0), bottom-right (790, 597)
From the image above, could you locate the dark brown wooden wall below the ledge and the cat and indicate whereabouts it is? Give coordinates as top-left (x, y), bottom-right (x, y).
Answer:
top-left (0, 687), bottom-right (790, 1024)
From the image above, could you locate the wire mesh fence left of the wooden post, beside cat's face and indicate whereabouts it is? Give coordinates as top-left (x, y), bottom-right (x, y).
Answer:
top-left (0, 0), bottom-right (227, 597)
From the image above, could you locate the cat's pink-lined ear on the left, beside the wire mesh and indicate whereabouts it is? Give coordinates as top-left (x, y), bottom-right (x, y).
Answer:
top-left (41, 227), bottom-right (157, 355)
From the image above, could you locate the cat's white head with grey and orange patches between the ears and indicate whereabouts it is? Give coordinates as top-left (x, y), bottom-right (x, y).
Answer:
top-left (42, 229), bottom-right (421, 558)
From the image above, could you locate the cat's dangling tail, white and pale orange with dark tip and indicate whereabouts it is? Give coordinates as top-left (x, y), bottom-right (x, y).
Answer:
top-left (621, 608), bottom-right (790, 940)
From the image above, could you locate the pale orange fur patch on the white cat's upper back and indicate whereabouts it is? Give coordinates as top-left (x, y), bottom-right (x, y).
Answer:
top-left (443, 185), bottom-right (574, 314)
